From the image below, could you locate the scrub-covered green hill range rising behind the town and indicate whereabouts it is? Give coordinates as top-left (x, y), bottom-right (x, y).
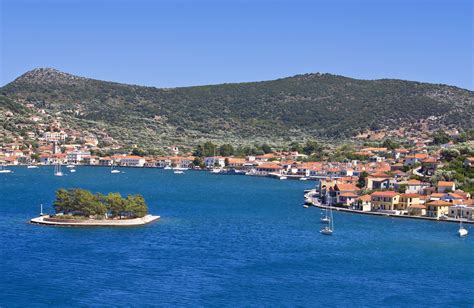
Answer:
top-left (0, 69), bottom-right (474, 143)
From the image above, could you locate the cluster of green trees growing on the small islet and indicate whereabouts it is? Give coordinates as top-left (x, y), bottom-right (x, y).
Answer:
top-left (54, 188), bottom-right (148, 218)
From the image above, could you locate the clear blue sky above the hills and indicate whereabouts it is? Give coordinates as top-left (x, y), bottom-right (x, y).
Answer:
top-left (0, 0), bottom-right (474, 90)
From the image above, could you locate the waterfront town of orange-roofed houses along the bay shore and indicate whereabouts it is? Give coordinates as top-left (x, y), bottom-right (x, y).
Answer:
top-left (0, 113), bottom-right (474, 221)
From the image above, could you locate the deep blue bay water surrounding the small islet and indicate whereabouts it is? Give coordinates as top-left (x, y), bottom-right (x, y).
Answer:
top-left (0, 167), bottom-right (474, 307)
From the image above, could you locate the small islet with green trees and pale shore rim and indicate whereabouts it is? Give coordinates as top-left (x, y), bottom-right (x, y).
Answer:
top-left (30, 189), bottom-right (160, 227)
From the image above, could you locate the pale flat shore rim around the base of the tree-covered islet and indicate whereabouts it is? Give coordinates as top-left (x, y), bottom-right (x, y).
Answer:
top-left (30, 215), bottom-right (160, 227)
